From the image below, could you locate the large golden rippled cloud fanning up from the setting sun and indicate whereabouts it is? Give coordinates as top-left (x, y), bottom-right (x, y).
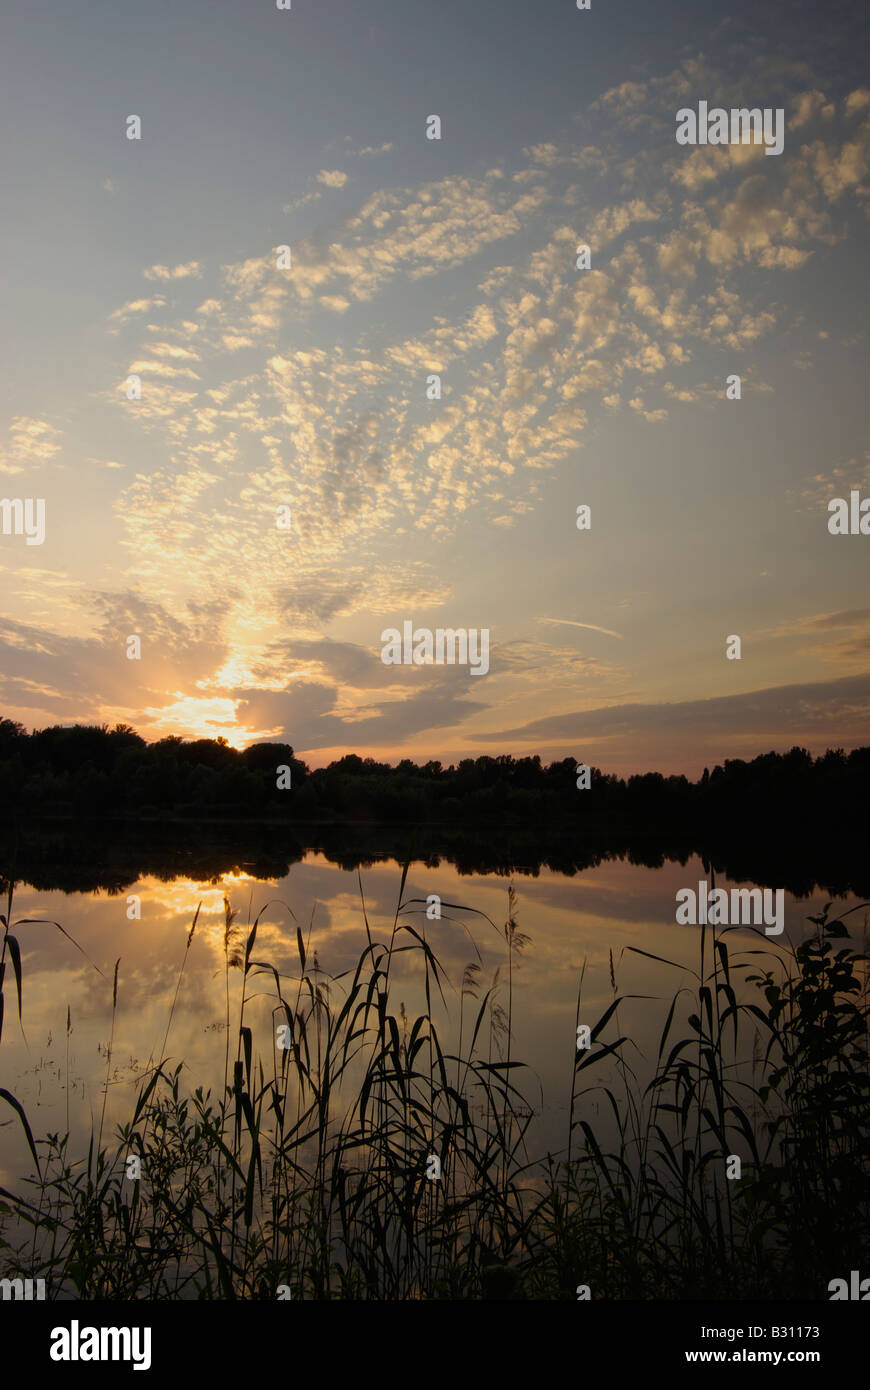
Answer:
top-left (61, 61), bottom-right (867, 772)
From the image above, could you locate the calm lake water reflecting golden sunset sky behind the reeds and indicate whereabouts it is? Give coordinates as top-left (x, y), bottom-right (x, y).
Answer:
top-left (0, 853), bottom-right (864, 1187)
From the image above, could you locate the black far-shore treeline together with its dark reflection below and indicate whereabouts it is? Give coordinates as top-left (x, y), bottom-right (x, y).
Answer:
top-left (0, 720), bottom-right (870, 897)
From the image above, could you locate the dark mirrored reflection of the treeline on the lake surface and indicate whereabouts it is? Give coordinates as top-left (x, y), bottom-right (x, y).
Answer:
top-left (0, 820), bottom-right (870, 898)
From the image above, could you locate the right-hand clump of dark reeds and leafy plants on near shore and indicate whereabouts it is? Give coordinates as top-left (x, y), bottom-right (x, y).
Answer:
top-left (538, 904), bottom-right (870, 1298)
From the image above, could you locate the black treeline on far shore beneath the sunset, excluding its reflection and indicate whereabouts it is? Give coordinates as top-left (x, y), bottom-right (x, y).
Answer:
top-left (0, 720), bottom-right (870, 830)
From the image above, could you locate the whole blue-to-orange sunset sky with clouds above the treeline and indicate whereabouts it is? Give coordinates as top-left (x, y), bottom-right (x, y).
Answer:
top-left (0, 0), bottom-right (870, 777)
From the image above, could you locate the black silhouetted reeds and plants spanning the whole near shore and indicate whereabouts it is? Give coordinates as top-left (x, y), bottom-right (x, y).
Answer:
top-left (0, 867), bottom-right (870, 1300)
